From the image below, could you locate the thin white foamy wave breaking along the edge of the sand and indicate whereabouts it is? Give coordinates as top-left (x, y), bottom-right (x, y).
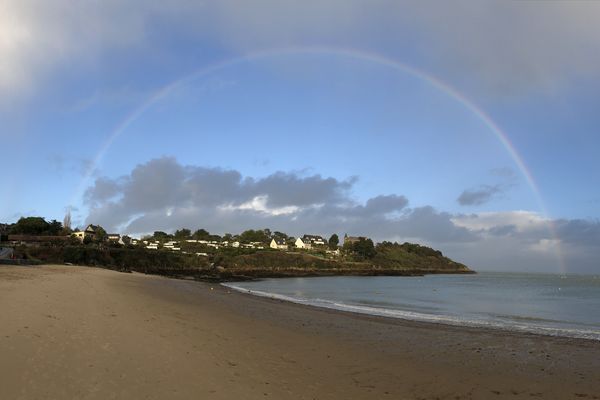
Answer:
top-left (221, 283), bottom-right (600, 341)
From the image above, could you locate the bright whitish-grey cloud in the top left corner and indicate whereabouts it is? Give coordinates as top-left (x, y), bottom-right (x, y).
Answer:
top-left (0, 0), bottom-right (148, 97)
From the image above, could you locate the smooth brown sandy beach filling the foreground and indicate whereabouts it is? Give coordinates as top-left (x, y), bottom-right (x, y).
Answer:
top-left (0, 266), bottom-right (600, 399)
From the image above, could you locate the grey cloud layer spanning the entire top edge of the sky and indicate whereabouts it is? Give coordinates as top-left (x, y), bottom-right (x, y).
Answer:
top-left (0, 0), bottom-right (600, 98)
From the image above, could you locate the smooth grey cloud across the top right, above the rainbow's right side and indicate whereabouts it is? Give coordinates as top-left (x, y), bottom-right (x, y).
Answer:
top-left (209, 0), bottom-right (600, 95)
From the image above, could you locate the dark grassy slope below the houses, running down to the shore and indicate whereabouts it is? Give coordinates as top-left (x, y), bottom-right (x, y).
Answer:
top-left (16, 245), bottom-right (471, 279)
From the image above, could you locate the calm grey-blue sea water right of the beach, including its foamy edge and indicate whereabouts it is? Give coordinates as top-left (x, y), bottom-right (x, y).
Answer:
top-left (224, 272), bottom-right (600, 340)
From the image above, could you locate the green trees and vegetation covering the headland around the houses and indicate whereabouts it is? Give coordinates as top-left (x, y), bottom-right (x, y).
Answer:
top-left (4, 217), bottom-right (472, 280)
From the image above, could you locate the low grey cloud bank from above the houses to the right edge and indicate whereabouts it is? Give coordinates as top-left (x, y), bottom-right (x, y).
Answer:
top-left (85, 157), bottom-right (600, 272)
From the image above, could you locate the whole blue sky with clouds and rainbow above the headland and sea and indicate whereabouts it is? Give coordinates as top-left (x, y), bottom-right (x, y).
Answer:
top-left (0, 0), bottom-right (600, 273)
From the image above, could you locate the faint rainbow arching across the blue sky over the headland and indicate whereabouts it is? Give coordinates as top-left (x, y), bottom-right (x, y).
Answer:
top-left (72, 46), bottom-right (566, 273)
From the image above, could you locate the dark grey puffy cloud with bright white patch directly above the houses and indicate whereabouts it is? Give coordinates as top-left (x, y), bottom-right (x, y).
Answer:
top-left (85, 157), bottom-right (473, 241)
